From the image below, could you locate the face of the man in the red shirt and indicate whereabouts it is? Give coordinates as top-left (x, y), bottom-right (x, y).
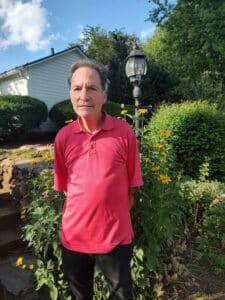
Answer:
top-left (70, 67), bottom-right (107, 119)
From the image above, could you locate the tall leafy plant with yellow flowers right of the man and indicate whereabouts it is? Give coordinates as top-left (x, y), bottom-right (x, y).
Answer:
top-left (120, 110), bottom-right (184, 299)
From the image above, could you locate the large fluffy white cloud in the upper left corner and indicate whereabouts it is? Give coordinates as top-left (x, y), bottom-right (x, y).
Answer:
top-left (0, 0), bottom-right (56, 51)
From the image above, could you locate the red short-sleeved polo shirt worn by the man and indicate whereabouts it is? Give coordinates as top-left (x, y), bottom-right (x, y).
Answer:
top-left (54, 114), bottom-right (143, 253)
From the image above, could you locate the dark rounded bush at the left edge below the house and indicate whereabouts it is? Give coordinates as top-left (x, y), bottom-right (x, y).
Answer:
top-left (0, 95), bottom-right (48, 137)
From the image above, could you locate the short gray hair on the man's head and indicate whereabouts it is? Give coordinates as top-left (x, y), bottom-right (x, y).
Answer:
top-left (68, 59), bottom-right (109, 91)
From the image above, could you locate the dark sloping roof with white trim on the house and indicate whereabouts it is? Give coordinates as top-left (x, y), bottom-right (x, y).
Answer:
top-left (0, 46), bottom-right (87, 78)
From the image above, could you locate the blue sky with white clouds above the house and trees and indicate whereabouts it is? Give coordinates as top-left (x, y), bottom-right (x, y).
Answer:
top-left (0, 0), bottom-right (158, 73)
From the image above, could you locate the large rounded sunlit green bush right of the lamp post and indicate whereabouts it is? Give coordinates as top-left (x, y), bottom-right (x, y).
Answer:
top-left (148, 101), bottom-right (225, 181)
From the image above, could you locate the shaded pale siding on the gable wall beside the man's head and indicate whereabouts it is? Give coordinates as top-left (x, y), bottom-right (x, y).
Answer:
top-left (28, 51), bottom-right (83, 109)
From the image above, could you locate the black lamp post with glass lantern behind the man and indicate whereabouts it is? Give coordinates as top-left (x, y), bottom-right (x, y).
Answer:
top-left (125, 43), bottom-right (147, 136)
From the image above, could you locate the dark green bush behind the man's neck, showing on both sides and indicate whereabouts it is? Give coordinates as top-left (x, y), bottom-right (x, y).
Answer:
top-left (49, 100), bottom-right (133, 127)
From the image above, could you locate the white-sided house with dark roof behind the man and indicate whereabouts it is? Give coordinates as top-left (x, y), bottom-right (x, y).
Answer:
top-left (0, 47), bottom-right (87, 129)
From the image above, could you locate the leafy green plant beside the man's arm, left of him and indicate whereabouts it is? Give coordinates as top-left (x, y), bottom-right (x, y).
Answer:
top-left (23, 169), bottom-right (67, 300)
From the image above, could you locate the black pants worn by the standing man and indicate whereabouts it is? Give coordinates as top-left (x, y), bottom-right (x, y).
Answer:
top-left (62, 244), bottom-right (133, 300)
